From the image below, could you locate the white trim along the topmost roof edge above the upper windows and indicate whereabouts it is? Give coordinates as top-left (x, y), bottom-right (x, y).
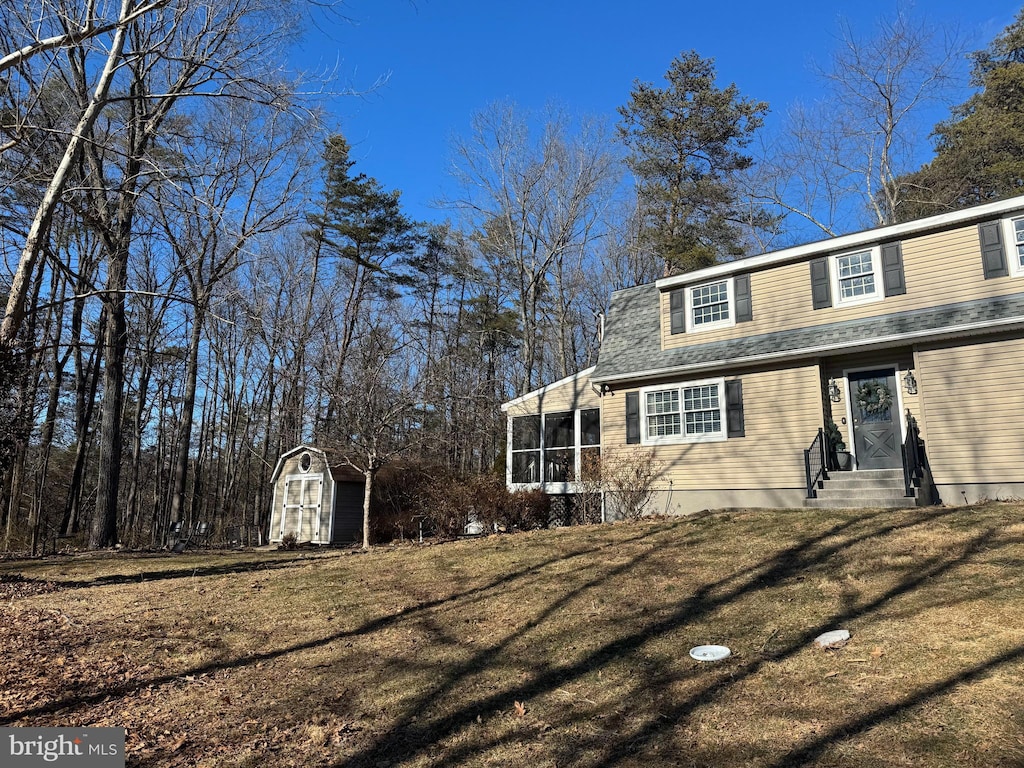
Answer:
top-left (654, 197), bottom-right (1024, 291)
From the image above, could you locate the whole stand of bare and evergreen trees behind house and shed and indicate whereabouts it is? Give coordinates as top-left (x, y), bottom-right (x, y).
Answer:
top-left (0, 0), bottom-right (1024, 550)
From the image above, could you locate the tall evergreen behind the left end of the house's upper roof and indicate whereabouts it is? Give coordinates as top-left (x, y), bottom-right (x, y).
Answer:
top-left (618, 51), bottom-right (768, 272)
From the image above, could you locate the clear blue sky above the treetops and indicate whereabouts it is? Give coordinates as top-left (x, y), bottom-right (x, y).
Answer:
top-left (294, 0), bottom-right (1021, 221)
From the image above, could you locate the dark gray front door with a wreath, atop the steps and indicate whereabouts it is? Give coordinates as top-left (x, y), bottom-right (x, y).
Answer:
top-left (850, 369), bottom-right (903, 469)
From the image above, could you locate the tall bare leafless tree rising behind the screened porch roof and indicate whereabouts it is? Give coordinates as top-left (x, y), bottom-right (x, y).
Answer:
top-left (451, 103), bottom-right (618, 392)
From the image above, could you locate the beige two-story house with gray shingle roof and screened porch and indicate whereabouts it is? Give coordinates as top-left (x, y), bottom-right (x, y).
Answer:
top-left (503, 197), bottom-right (1024, 513)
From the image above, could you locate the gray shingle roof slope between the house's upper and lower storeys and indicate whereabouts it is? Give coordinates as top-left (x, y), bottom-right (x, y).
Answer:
top-left (591, 284), bottom-right (1024, 381)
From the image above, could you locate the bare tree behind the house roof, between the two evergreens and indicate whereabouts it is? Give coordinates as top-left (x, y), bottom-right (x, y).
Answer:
top-left (746, 11), bottom-right (964, 237)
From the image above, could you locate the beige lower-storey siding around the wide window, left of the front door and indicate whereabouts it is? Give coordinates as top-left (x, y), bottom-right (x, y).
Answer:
top-left (601, 365), bottom-right (822, 490)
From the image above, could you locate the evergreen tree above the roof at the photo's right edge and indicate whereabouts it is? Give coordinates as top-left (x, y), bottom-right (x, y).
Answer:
top-left (898, 9), bottom-right (1024, 221)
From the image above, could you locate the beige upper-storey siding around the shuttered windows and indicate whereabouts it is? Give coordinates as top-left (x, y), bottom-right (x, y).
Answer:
top-left (660, 224), bottom-right (1024, 349)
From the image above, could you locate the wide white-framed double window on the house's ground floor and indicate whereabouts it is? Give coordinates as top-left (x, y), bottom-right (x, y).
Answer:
top-left (641, 379), bottom-right (726, 443)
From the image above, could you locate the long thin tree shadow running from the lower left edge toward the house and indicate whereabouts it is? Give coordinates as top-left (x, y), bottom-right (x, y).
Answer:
top-left (0, 526), bottom-right (665, 726)
